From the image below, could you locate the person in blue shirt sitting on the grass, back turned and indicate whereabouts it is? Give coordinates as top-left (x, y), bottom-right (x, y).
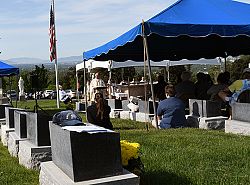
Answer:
top-left (157, 85), bottom-right (186, 129)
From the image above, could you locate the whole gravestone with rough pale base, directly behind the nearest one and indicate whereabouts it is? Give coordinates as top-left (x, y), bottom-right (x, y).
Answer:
top-left (18, 110), bottom-right (54, 170)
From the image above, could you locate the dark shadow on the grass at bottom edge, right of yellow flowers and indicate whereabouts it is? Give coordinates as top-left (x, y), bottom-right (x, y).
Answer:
top-left (140, 171), bottom-right (192, 185)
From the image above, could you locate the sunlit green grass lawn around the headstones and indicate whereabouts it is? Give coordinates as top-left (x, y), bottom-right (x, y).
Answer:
top-left (0, 101), bottom-right (250, 185)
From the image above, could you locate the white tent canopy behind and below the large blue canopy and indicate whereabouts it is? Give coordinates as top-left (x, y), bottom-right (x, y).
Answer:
top-left (76, 58), bottom-right (221, 71)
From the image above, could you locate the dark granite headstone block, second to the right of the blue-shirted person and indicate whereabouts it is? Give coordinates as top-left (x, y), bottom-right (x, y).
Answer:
top-left (203, 100), bottom-right (222, 117)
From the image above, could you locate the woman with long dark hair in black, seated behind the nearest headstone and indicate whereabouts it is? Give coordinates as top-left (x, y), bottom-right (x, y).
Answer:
top-left (87, 93), bottom-right (113, 129)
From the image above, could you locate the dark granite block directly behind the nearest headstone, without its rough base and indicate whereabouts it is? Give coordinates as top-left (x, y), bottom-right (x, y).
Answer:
top-left (26, 112), bottom-right (52, 146)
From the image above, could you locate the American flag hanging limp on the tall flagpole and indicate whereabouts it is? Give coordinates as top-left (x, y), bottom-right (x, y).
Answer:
top-left (49, 5), bottom-right (56, 62)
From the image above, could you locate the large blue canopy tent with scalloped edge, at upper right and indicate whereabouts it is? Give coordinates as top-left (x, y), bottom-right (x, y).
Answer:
top-left (83, 0), bottom-right (250, 127)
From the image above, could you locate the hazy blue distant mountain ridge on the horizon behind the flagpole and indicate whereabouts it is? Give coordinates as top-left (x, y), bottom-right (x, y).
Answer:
top-left (2, 56), bottom-right (82, 65)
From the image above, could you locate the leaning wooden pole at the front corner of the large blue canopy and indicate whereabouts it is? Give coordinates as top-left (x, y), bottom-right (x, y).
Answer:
top-left (142, 20), bottom-right (158, 129)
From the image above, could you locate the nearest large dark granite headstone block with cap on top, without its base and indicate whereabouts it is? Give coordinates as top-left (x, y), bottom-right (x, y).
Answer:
top-left (50, 122), bottom-right (122, 182)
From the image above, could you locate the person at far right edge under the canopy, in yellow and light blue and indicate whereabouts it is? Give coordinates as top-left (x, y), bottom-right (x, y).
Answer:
top-left (219, 68), bottom-right (250, 104)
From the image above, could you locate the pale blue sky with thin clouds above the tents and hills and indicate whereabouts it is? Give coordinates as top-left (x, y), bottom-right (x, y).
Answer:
top-left (0, 0), bottom-right (250, 60)
